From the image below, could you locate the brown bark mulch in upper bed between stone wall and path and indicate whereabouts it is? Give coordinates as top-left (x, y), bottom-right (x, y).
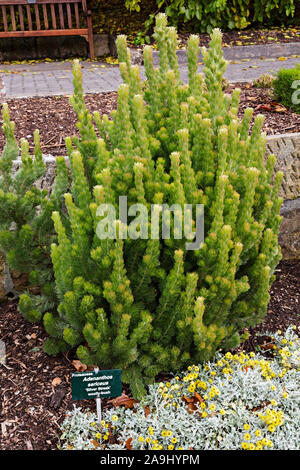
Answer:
top-left (0, 83), bottom-right (300, 155)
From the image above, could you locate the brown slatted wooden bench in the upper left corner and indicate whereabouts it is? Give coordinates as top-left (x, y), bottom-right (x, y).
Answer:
top-left (0, 0), bottom-right (94, 59)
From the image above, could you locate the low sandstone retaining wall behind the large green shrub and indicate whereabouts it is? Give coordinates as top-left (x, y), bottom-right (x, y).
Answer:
top-left (0, 134), bottom-right (300, 300)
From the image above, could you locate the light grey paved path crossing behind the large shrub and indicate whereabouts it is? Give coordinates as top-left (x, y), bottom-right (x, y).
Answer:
top-left (0, 43), bottom-right (300, 98)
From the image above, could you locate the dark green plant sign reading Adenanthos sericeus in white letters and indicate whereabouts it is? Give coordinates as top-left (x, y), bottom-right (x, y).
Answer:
top-left (71, 369), bottom-right (122, 400)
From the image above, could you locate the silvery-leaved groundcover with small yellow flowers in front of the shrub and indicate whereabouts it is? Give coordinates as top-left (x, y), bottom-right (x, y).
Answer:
top-left (60, 327), bottom-right (300, 450)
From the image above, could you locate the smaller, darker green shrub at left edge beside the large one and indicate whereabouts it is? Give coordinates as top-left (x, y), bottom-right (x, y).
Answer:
top-left (0, 104), bottom-right (68, 321)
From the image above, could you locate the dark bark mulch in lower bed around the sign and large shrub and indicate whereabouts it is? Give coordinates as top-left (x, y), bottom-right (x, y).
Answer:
top-left (0, 261), bottom-right (300, 450)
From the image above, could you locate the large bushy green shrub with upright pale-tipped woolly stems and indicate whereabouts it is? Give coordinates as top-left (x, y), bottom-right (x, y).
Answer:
top-left (37, 14), bottom-right (282, 396)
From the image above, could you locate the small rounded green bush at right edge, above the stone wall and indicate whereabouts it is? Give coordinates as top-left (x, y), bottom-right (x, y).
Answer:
top-left (272, 65), bottom-right (300, 113)
